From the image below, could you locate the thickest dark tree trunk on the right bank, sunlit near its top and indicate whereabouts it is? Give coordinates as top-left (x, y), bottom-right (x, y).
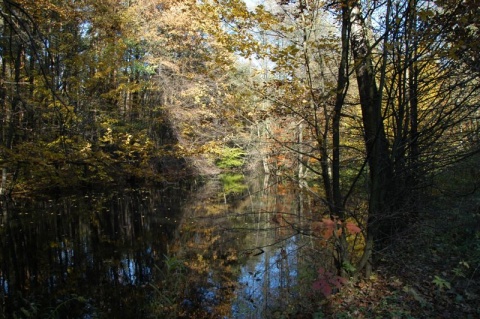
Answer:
top-left (343, 1), bottom-right (393, 276)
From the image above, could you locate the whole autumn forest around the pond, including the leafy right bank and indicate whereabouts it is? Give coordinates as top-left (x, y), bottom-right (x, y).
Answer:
top-left (0, 0), bottom-right (480, 318)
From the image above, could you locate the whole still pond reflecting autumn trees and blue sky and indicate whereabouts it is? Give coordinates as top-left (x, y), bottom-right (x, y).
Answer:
top-left (0, 176), bottom-right (331, 318)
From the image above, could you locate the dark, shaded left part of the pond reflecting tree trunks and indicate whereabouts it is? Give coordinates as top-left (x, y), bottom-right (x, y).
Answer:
top-left (0, 189), bottom-right (185, 318)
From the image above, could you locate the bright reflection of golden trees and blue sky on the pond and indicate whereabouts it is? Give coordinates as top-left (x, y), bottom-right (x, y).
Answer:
top-left (175, 179), bottom-right (327, 318)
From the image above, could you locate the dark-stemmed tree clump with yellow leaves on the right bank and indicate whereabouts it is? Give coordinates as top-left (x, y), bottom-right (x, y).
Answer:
top-left (217, 1), bottom-right (478, 278)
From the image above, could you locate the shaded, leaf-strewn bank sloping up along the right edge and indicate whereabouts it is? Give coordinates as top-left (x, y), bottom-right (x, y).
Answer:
top-left (317, 162), bottom-right (480, 319)
